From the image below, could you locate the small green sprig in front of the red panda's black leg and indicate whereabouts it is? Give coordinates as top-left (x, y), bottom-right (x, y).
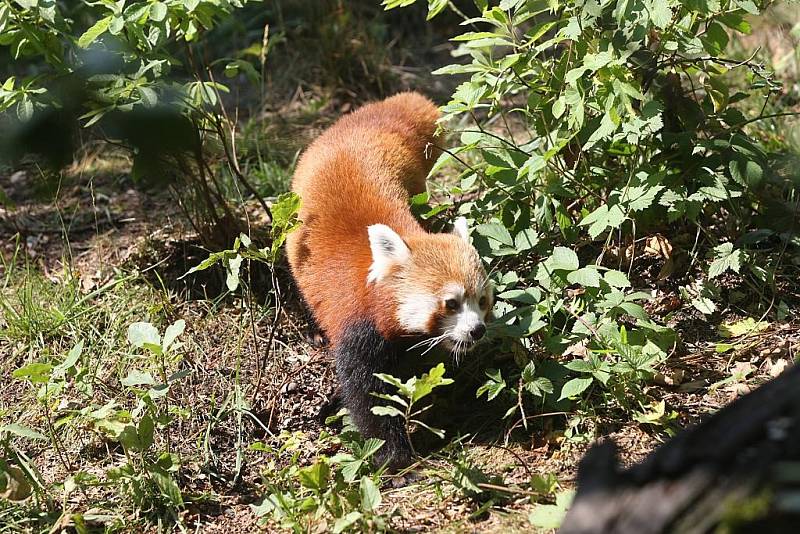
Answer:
top-left (372, 363), bottom-right (453, 449)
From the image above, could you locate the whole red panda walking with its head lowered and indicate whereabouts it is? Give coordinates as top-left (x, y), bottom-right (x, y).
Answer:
top-left (287, 92), bottom-right (493, 469)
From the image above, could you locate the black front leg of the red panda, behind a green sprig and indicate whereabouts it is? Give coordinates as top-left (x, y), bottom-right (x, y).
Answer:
top-left (334, 321), bottom-right (411, 470)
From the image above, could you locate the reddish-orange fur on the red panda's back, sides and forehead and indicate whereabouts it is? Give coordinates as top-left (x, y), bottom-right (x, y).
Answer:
top-left (287, 93), bottom-right (478, 345)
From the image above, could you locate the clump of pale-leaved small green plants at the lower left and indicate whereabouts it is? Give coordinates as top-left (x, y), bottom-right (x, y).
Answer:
top-left (9, 320), bottom-right (191, 520)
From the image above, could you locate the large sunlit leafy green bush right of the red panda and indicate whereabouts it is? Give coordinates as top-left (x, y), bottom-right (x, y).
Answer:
top-left (383, 0), bottom-right (798, 428)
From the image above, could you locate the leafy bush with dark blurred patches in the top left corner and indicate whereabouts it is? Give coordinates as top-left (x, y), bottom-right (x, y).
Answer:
top-left (0, 0), bottom-right (269, 244)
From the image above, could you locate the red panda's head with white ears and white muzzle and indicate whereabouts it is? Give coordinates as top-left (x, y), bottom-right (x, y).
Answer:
top-left (367, 218), bottom-right (494, 354)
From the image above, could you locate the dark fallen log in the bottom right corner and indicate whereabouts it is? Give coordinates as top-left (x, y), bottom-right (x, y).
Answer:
top-left (559, 365), bottom-right (800, 534)
